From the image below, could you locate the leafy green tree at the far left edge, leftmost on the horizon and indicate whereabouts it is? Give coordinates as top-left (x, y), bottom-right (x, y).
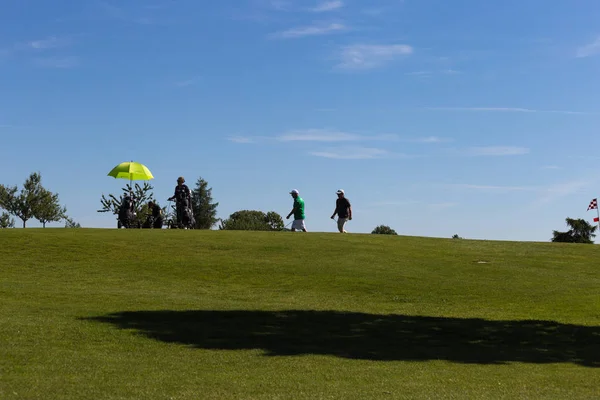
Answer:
top-left (0, 172), bottom-right (43, 228)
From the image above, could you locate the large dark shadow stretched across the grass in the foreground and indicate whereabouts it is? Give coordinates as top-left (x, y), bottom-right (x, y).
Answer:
top-left (86, 310), bottom-right (600, 367)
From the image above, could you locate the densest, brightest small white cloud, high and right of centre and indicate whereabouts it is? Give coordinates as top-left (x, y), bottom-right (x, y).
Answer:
top-left (338, 44), bottom-right (413, 70)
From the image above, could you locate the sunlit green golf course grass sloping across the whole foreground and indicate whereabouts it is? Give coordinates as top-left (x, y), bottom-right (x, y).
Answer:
top-left (0, 229), bottom-right (600, 400)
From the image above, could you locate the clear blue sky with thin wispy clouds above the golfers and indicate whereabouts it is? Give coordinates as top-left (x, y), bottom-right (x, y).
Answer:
top-left (0, 0), bottom-right (600, 241)
